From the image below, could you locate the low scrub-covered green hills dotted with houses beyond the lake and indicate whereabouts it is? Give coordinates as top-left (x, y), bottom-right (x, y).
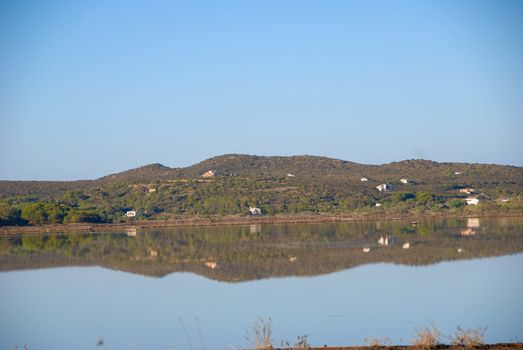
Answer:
top-left (0, 154), bottom-right (523, 225)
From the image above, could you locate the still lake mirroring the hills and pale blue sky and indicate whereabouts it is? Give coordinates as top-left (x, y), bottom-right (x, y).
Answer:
top-left (0, 218), bottom-right (523, 349)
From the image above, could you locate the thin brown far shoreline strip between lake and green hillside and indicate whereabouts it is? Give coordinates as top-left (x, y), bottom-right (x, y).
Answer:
top-left (0, 212), bottom-right (523, 235)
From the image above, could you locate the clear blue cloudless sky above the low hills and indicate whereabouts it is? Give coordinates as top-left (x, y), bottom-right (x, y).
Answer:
top-left (0, 0), bottom-right (523, 180)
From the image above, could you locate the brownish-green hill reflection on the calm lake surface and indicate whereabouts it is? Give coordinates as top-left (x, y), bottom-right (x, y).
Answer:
top-left (0, 218), bottom-right (523, 282)
